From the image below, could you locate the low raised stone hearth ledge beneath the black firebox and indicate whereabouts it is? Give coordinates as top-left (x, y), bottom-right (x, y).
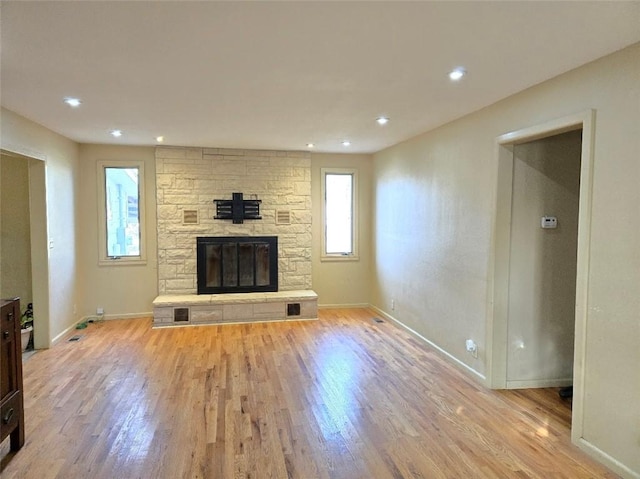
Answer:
top-left (153, 290), bottom-right (318, 327)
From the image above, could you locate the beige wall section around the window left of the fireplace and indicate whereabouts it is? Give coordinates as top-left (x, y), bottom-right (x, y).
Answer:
top-left (78, 145), bottom-right (158, 318)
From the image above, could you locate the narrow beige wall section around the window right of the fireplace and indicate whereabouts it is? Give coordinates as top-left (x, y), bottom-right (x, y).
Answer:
top-left (311, 153), bottom-right (373, 307)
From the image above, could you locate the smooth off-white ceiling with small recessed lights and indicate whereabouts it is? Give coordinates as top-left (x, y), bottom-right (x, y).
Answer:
top-left (0, 0), bottom-right (640, 153)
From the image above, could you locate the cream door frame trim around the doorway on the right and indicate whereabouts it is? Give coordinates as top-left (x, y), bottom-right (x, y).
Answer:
top-left (486, 110), bottom-right (595, 442)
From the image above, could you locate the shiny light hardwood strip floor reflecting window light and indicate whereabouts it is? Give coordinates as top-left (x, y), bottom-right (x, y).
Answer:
top-left (0, 310), bottom-right (617, 479)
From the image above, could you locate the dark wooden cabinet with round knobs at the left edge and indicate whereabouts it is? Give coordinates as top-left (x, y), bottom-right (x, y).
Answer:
top-left (0, 298), bottom-right (24, 451)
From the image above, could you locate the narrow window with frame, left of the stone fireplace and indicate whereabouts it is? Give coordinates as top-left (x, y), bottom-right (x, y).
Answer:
top-left (98, 162), bottom-right (146, 264)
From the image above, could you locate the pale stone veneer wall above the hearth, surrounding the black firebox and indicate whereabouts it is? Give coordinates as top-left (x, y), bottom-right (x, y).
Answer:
top-left (156, 147), bottom-right (311, 295)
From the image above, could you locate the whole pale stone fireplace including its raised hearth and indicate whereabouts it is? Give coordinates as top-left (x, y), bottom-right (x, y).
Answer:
top-left (153, 147), bottom-right (317, 326)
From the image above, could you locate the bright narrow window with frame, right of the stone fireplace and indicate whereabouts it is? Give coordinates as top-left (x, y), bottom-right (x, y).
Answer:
top-left (322, 168), bottom-right (358, 260)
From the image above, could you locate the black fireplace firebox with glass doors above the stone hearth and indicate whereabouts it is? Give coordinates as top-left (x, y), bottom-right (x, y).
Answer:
top-left (197, 236), bottom-right (278, 294)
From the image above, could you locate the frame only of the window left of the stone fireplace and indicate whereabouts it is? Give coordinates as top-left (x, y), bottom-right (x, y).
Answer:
top-left (96, 160), bottom-right (147, 266)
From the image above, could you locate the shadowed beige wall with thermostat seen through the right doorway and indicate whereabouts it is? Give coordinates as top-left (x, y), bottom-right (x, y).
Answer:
top-left (507, 131), bottom-right (582, 388)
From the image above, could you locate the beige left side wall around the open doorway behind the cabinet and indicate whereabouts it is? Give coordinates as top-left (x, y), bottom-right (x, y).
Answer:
top-left (0, 108), bottom-right (79, 347)
